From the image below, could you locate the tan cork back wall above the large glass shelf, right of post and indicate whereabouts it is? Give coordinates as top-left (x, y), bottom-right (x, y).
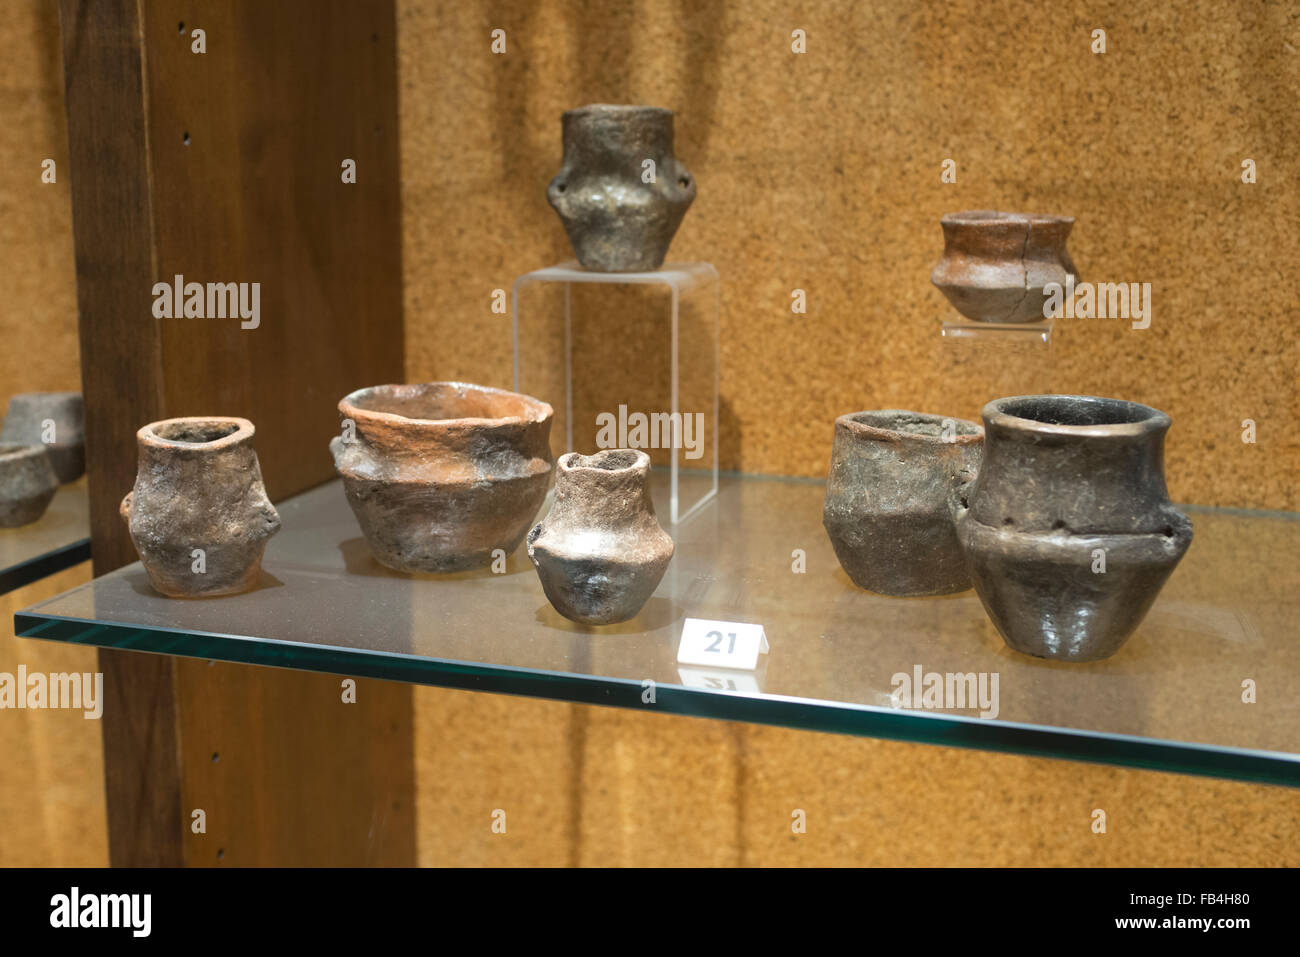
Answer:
top-left (399, 0), bottom-right (1300, 510)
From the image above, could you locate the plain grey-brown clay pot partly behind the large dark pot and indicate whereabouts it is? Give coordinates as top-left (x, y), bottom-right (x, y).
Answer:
top-left (822, 408), bottom-right (984, 596)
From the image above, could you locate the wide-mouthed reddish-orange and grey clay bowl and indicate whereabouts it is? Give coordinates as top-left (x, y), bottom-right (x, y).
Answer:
top-left (330, 382), bottom-right (553, 572)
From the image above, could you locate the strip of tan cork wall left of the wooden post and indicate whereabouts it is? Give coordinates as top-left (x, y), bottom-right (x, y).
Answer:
top-left (0, 0), bottom-right (108, 867)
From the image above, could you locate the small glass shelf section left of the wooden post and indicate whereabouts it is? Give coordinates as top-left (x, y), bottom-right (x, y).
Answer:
top-left (0, 476), bottom-right (90, 594)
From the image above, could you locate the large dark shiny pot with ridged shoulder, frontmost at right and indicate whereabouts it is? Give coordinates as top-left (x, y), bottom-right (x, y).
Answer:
top-left (957, 395), bottom-right (1192, 662)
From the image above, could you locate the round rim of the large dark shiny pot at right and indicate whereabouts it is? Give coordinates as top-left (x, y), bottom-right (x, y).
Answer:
top-left (982, 393), bottom-right (1171, 438)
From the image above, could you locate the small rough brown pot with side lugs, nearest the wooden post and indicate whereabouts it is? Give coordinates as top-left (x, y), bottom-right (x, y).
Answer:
top-left (121, 416), bottom-right (280, 598)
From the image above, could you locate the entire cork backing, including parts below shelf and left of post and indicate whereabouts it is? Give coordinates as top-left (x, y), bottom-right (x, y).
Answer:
top-left (0, 0), bottom-right (1300, 866)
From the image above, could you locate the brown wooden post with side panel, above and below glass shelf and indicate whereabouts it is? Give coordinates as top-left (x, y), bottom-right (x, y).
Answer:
top-left (60, 0), bottom-right (415, 865)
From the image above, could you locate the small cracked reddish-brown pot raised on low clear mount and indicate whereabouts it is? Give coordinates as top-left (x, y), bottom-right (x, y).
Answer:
top-left (930, 209), bottom-right (1079, 322)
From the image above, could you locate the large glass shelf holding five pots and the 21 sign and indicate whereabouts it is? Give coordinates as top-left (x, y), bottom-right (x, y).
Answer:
top-left (16, 473), bottom-right (1300, 785)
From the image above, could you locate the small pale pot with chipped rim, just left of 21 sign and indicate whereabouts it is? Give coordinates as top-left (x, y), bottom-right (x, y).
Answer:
top-left (528, 449), bottom-right (673, 624)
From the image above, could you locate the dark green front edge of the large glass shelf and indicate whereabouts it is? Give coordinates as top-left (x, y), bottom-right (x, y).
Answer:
top-left (14, 605), bottom-right (1300, 788)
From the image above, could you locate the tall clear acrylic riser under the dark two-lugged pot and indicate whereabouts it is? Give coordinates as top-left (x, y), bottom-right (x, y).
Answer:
top-left (511, 263), bottom-right (719, 524)
